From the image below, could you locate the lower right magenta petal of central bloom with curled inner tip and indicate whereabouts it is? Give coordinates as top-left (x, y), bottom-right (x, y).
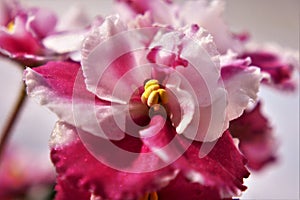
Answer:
top-left (140, 116), bottom-right (249, 199)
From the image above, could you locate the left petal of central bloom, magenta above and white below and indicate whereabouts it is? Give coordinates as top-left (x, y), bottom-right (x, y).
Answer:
top-left (24, 62), bottom-right (126, 139)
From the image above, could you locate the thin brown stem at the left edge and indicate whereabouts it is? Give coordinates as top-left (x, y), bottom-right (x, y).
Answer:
top-left (0, 83), bottom-right (26, 161)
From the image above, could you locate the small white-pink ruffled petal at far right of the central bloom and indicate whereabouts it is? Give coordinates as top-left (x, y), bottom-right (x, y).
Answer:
top-left (221, 52), bottom-right (263, 120)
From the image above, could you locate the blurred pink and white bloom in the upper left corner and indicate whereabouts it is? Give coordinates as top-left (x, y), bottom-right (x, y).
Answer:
top-left (0, 1), bottom-right (88, 66)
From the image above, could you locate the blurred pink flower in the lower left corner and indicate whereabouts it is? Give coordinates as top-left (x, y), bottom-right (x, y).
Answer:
top-left (0, 146), bottom-right (55, 200)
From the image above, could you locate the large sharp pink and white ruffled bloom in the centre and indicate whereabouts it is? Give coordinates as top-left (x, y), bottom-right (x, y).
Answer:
top-left (24, 16), bottom-right (262, 200)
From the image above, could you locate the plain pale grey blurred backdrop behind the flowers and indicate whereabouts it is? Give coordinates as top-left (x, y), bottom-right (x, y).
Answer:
top-left (0, 0), bottom-right (299, 199)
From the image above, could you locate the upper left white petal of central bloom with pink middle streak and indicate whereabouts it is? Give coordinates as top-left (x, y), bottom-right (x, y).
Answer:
top-left (82, 16), bottom-right (156, 104)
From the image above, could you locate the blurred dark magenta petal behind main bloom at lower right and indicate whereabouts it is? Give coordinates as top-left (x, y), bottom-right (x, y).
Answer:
top-left (230, 103), bottom-right (278, 170)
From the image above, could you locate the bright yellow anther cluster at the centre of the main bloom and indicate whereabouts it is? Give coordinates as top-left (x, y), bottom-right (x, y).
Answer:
top-left (141, 79), bottom-right (168, 107)
